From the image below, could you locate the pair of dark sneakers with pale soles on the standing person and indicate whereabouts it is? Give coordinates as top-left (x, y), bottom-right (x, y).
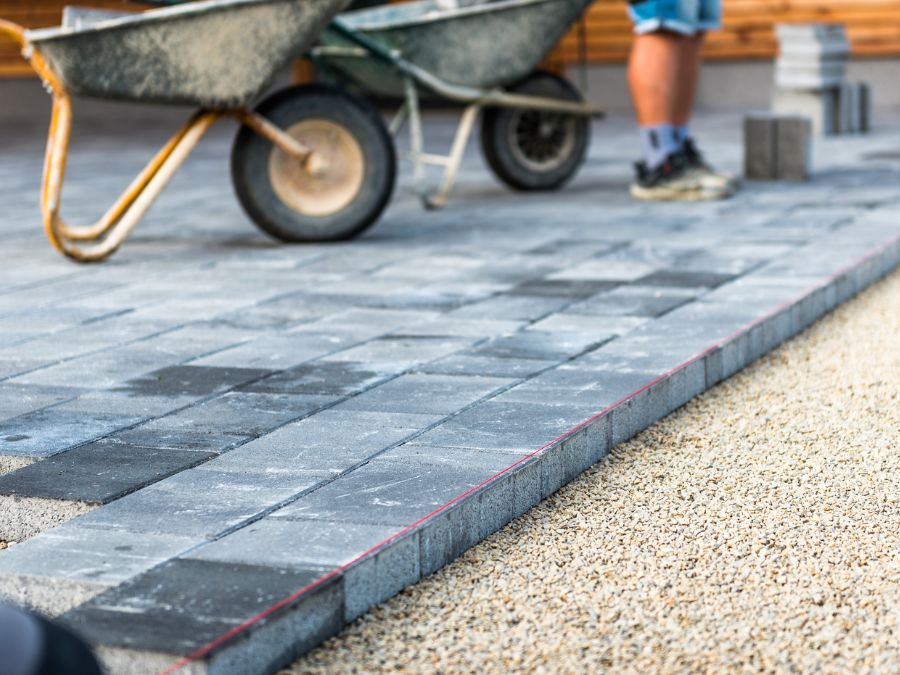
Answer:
top-left (631, 151), bottom-right (734, 201)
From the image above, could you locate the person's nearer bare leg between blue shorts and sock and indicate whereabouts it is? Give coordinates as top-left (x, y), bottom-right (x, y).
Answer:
top-left (628, 31), bottom-right (684, 126)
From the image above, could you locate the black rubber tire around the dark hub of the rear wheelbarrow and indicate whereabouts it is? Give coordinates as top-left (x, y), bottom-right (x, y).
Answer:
top-left (481, 70), bottom-right (591, 192)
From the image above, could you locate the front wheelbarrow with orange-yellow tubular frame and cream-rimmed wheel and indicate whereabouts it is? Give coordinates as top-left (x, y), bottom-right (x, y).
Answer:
top-left (0, 0), bottom-right (396, 262)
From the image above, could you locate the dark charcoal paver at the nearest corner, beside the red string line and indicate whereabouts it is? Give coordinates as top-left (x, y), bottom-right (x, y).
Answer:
top-left (62, 560), bottom-right (343, 655)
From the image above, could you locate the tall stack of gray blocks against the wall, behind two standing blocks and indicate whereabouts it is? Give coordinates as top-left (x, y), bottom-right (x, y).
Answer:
top-left (773, 24), bottom-right (872, 136)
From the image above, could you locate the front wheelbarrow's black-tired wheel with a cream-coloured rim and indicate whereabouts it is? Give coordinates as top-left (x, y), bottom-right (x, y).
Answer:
top-left (231, 84), bottom-right (397, 243)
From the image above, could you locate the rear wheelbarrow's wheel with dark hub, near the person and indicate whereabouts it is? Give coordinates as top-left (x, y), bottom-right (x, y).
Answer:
top-left (481, 71), bottom-right (591, 192)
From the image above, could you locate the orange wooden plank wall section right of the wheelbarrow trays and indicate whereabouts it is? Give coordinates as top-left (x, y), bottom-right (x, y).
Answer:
top-left (552, 0), bottom-right (900, 63)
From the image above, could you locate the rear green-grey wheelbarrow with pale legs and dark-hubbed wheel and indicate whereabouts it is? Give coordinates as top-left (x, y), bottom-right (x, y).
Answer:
top-left (311, 0), bottom-right (603, 208)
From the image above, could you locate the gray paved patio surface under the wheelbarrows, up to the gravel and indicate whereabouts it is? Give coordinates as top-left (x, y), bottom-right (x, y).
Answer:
top-left (0, 92), bottom-right (900, 673)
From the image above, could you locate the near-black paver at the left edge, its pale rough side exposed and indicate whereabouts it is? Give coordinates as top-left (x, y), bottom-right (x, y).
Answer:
top-left (0, 441), bottom-right (213, 504)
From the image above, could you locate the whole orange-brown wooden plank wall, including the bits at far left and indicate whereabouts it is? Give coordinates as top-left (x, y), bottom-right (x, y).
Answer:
top-left (0, 0), bottom-right (900, 77)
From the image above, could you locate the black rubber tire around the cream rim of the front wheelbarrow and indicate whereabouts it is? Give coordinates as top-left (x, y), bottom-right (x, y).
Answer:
top-left (231, 84), bottom-right (397, 243)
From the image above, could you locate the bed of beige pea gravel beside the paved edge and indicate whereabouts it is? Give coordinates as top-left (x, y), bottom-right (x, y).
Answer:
top-left (286, 273), bottom-right (900, 673)
